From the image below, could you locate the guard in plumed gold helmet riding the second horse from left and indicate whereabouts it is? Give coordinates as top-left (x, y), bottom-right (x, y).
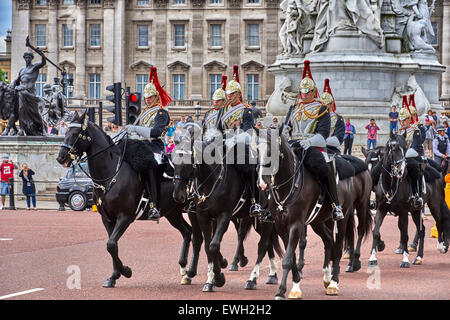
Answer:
top-left (220, 65), bottom-right (262, 216)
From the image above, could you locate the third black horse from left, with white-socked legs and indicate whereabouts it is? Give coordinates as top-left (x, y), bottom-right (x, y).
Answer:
top-left (255, 128), bottom-right (360, 299)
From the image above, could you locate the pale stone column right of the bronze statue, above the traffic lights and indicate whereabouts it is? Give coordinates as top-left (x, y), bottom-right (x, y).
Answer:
top-left (74, 1), bottom-right (87, 99)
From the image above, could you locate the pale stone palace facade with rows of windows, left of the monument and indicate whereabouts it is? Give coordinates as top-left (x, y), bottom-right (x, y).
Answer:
top-left (12, 0), bottom-right (282, 105)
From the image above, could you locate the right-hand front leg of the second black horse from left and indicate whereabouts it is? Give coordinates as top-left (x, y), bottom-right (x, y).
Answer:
top-left (209, 212), bottom-right (231, 288)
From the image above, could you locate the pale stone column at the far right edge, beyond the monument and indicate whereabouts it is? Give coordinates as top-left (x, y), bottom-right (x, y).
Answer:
top-left (441, 1), bottom-right (450, 99)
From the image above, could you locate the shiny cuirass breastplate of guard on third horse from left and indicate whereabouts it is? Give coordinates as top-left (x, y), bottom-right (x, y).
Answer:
top-left (290, 101), bottom-right (322, 139)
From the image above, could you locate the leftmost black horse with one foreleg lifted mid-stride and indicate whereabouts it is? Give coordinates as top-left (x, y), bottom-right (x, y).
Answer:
top-left (57, 112), bottom-right (194, 288)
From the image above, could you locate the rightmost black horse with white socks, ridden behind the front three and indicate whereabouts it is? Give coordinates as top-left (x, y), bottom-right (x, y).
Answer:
top-left (369, 132), bottom-right (450, 268)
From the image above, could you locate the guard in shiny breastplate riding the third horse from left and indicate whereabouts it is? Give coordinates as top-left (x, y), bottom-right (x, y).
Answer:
top-left (283, 60), bottom-right (344, 221)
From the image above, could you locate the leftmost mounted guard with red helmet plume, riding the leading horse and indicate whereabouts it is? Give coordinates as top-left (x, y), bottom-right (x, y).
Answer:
top-left (125, 67), bottom-right (172, 220)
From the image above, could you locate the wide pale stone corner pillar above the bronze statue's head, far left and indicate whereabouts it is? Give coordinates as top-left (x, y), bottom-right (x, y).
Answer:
top-left (10, 1), bottom-right (30, 81)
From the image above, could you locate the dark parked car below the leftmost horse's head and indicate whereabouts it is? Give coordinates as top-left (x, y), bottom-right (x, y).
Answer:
top-left (56, 163), bottom-right (94, 211)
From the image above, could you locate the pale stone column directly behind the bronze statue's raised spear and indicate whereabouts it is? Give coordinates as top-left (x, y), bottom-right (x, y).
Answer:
top-left (47, 1), bottom-right (61, 84)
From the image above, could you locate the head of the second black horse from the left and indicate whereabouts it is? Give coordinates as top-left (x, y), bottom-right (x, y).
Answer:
top-left (172, 122), bottom-right (201, 203)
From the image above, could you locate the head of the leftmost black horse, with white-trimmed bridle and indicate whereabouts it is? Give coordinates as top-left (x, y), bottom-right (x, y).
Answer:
top-left (56, 110), bottom-right (92, 167)
